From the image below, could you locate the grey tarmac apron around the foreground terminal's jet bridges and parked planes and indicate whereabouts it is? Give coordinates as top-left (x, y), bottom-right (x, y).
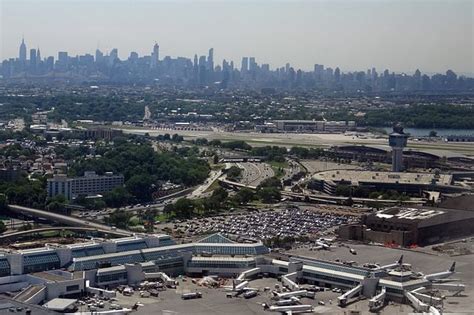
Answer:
top-left (111, 244), bottom-right (474, 315)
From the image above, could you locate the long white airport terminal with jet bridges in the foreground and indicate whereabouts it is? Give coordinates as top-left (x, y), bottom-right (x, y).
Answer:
top-left (0, 234), bottom-right (464, 311)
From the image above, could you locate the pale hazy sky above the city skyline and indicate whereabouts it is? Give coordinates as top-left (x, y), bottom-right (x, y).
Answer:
top-left (0, 0), bottom-right (474, 73)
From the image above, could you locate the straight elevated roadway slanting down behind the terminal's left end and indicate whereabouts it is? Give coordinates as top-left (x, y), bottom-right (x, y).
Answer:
top-left (8, 205), bottom-right (133, 236)
